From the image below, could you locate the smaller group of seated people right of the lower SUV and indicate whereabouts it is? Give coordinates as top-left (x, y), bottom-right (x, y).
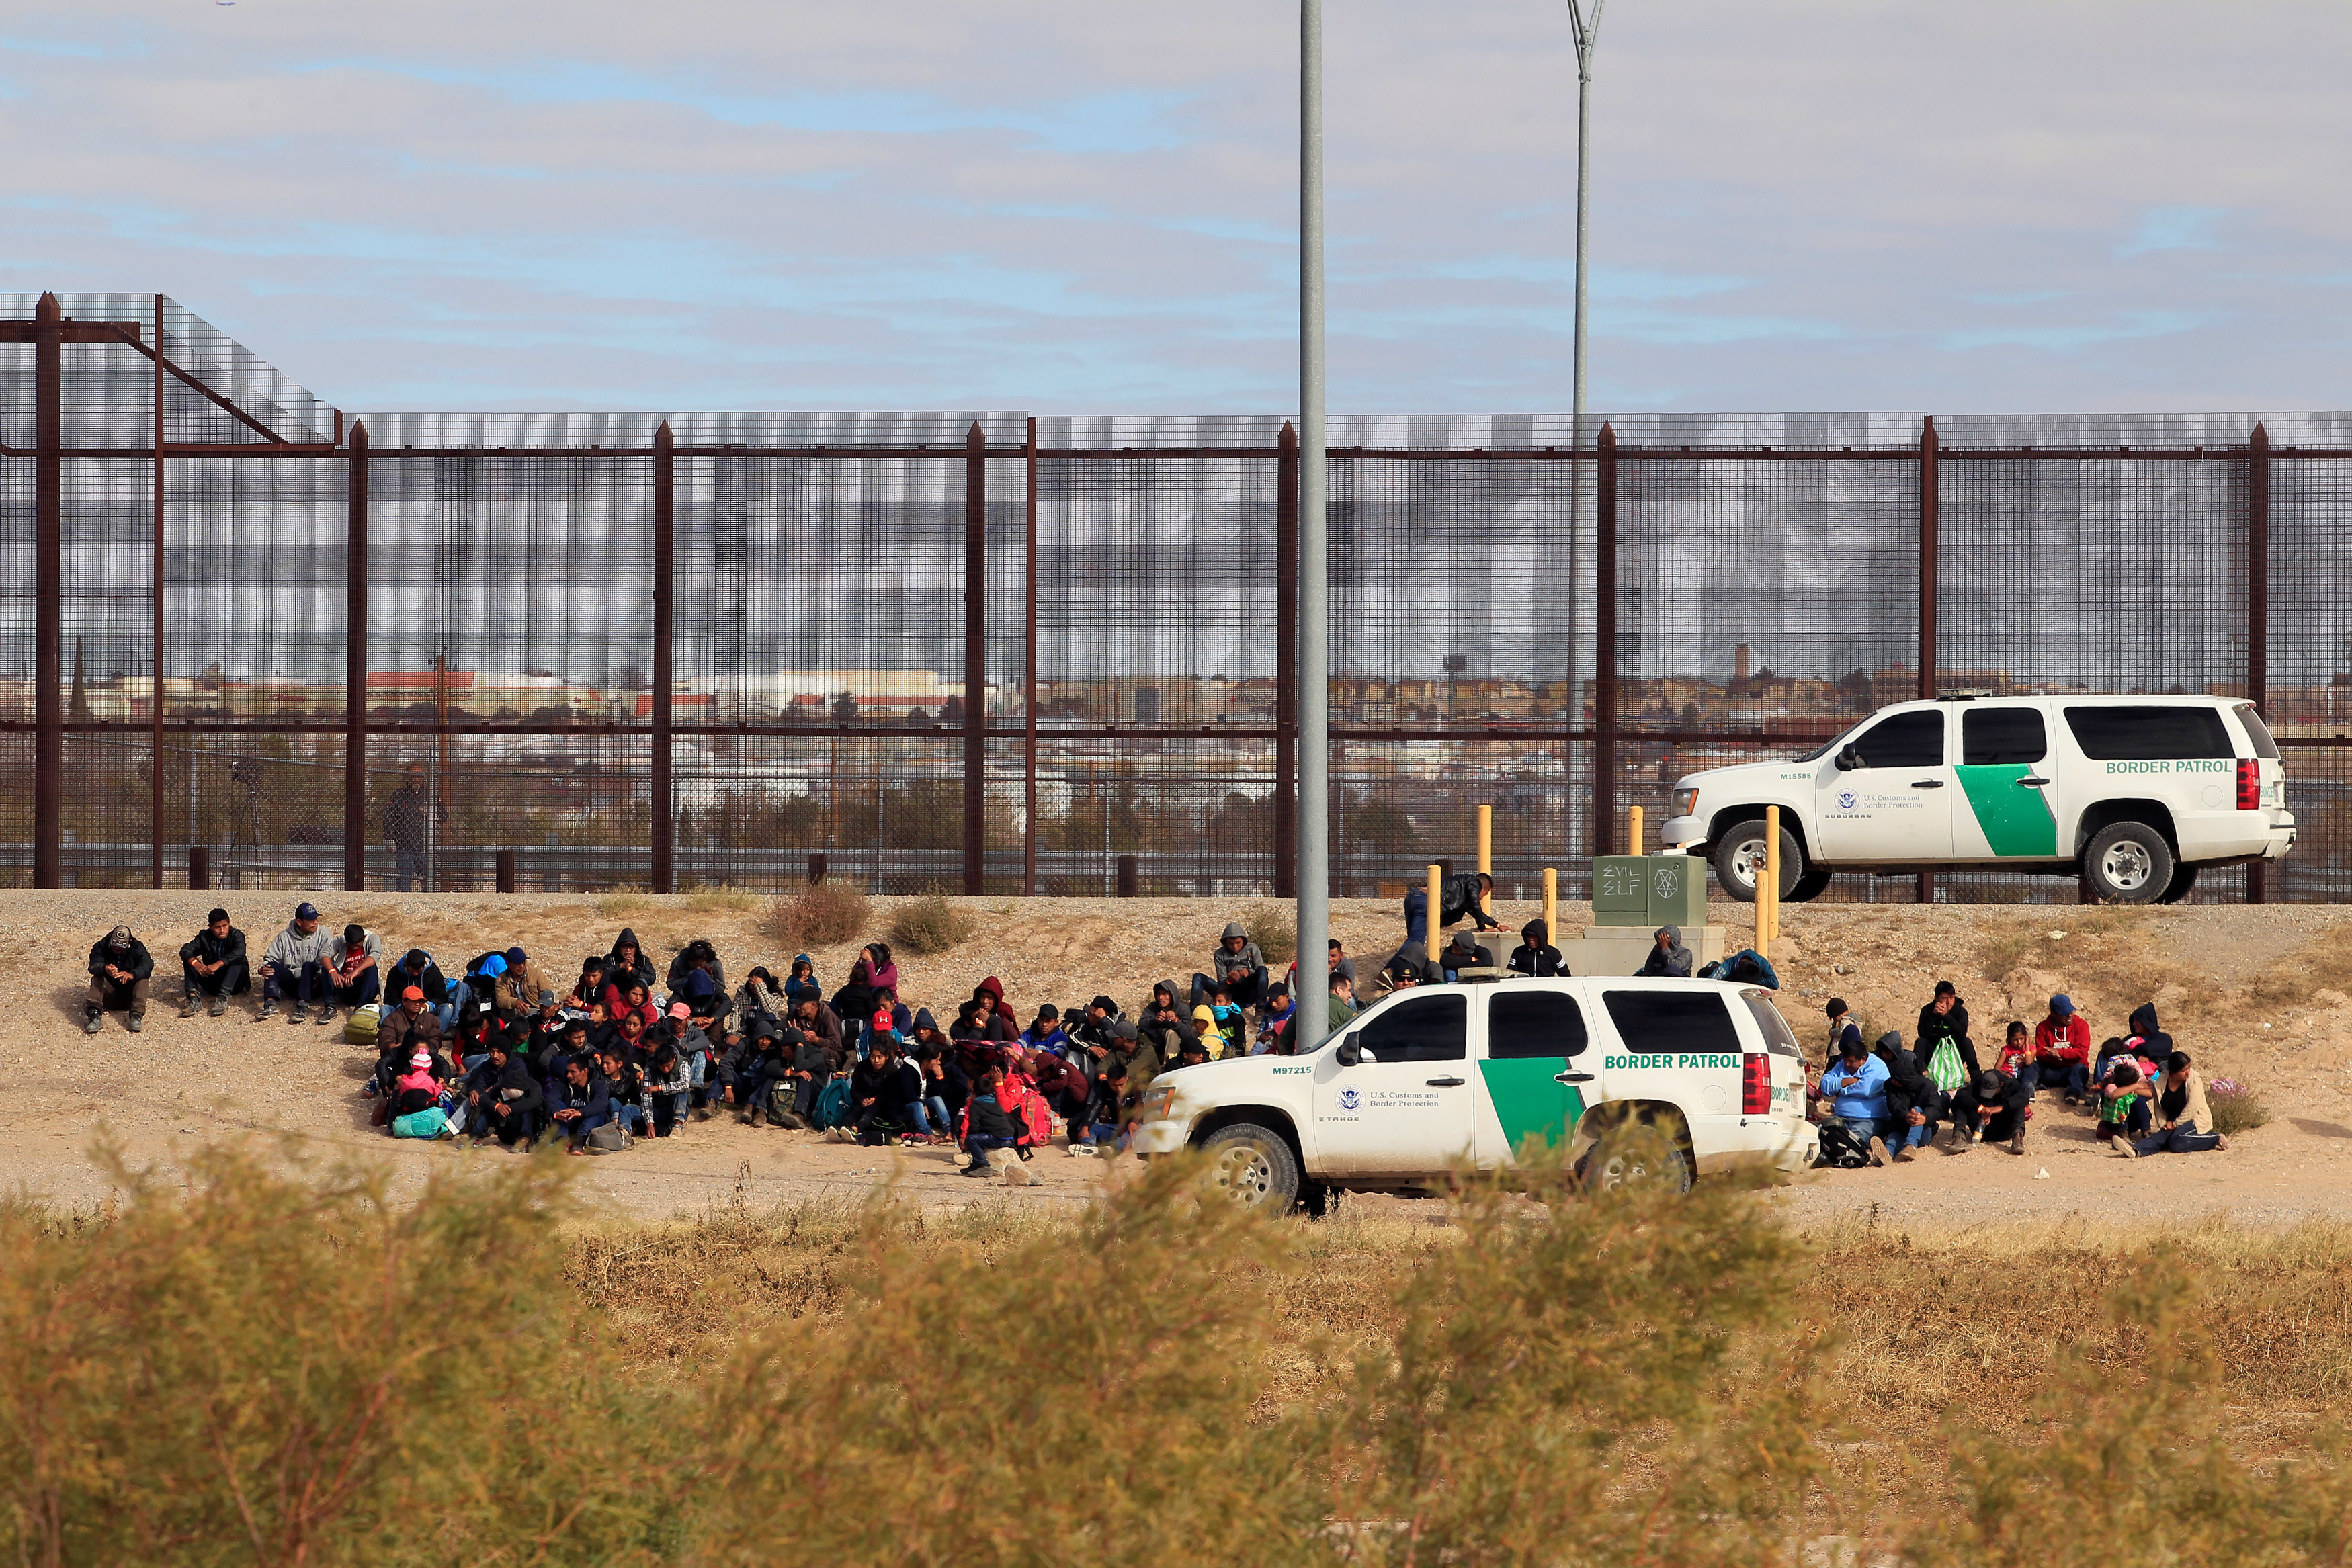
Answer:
top-left (1806, 980), bottom-right (2230, 1166)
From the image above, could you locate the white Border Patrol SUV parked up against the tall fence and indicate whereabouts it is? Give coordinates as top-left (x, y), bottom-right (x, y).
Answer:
top-left (1661, 696), bottom-right (2296, 903)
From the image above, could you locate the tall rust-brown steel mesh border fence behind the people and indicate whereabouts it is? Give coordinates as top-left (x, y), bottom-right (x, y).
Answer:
top-left (0, 296), bottom-right (2352, 900)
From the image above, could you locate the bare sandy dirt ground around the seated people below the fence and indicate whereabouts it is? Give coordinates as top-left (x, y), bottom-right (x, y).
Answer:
top-left (18, 891), bottom-right (2352, 1229)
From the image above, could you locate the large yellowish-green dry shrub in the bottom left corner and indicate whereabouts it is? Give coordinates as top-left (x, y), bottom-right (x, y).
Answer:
top-left (0, 1149), bottom-right (673, 1563)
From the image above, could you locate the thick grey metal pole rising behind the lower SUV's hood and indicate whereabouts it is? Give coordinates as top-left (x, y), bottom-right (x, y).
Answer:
top-left (1292, 0), bottom-right (1331, 1051)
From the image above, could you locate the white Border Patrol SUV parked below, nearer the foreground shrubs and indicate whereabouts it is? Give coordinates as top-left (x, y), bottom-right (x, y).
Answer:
top-left (1136, 978), bottom-right (1818, 1213)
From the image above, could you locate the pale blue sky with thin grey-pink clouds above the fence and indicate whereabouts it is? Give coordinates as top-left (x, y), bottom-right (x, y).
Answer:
top-left (0, 0), bottom-right (2352, 414)
